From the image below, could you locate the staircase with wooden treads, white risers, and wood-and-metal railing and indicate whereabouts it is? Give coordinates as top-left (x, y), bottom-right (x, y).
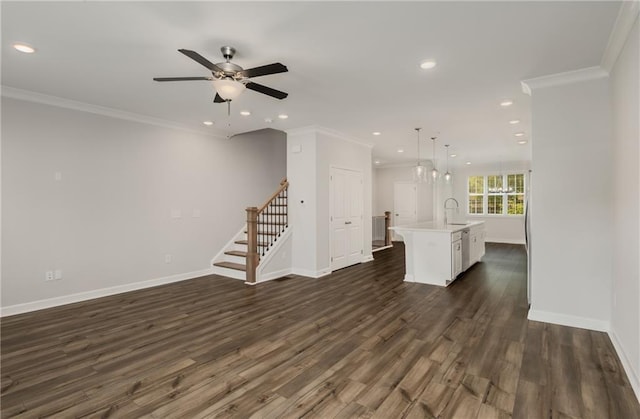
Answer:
top-left (213, 178), bottom-right (289, 283)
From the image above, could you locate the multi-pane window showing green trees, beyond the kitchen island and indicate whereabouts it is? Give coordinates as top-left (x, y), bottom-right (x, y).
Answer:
top-left (468, 173), bottom-right (525, 215)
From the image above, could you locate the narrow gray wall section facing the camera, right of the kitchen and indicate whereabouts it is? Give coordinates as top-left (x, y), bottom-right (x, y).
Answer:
top-left (529, 72), bottom-right (613, 330)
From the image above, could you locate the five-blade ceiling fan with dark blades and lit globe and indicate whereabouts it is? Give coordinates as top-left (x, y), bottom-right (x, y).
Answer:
top-left (153, 46), bottom-right (289, 103)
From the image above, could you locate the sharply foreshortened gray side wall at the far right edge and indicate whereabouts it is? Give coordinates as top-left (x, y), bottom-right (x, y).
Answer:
top-left (611, 18), bottom-right (640, 395)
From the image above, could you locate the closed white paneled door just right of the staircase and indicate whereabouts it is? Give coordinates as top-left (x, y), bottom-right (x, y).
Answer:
top-left (331, 168), bottom-right (364, 271)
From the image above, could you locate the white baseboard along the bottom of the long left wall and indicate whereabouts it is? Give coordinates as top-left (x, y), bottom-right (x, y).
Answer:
top-left (0, 269), bottom-right (212, 317)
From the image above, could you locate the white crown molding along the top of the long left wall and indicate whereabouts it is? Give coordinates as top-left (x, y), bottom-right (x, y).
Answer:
top-left (1, 86), bottom-right (228, 140)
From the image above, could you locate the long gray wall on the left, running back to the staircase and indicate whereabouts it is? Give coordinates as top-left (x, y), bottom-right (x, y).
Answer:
top-left (1, 98), bottom-right (286, 307)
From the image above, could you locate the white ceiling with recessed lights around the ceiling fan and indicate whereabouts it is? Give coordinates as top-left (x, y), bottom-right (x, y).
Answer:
top-left (2, 1), bottom-right (620, 167)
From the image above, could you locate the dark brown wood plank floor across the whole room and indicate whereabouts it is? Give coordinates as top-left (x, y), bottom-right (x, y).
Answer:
top-left (0, 244), bottom-right (640, 419)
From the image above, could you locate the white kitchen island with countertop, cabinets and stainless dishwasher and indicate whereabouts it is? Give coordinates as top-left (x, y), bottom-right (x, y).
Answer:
top-left (391, 221), bottom-right (485, 286)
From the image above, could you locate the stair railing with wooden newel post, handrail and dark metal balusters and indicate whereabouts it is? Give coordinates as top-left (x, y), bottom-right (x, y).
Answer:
top-left (246, 178), bottom-right (289, 283)
